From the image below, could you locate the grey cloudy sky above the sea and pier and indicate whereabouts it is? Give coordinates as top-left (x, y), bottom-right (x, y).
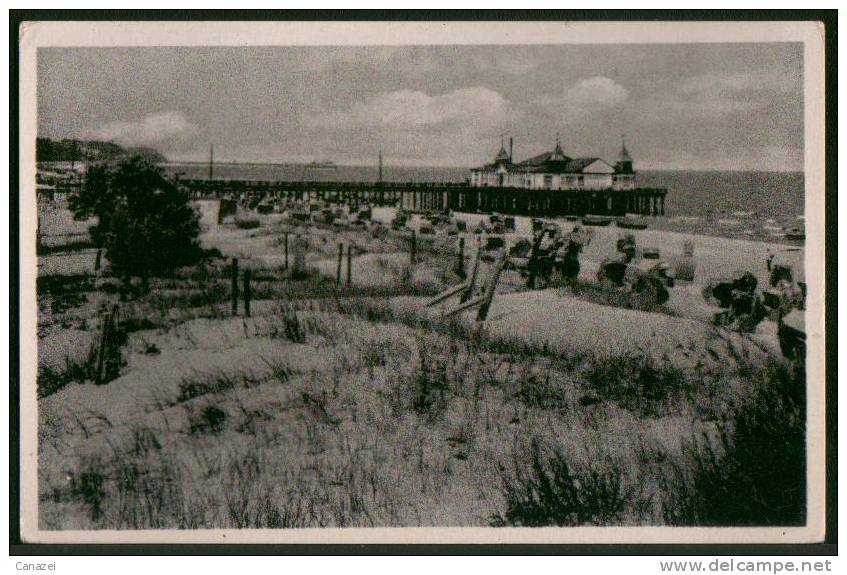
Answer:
top-left (38, 43), bottom-right (803, 171)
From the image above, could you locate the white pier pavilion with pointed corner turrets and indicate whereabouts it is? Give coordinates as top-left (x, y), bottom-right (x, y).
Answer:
top-left (470, 137), bottom-right (635, 190)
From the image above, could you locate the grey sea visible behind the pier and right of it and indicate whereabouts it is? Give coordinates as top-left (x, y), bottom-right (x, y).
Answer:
top-left (162, 162), bottom-right (805, 236)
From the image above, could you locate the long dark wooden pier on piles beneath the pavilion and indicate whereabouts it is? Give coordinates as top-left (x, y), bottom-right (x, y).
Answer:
top-left (179, 179), bottom-right (667, 217)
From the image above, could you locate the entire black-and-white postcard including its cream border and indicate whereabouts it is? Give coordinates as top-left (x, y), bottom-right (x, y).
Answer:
top-left (20, 18), bottom-right (825, 543)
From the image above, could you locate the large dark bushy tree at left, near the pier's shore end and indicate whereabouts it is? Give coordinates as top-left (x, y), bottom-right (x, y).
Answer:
top-left (69, 157), bottom-right (202, 281)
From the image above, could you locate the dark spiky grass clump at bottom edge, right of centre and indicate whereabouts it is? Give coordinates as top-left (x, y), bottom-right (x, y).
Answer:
top-left (492, 438), bottom-right (632, 527)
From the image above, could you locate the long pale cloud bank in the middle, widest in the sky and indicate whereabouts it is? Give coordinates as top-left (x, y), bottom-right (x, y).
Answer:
top-left (308, 87), bottom-right (511, 131)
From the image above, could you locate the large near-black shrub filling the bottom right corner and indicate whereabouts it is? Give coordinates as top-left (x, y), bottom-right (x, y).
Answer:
top-left (664, 366), bottom-right (806, 526)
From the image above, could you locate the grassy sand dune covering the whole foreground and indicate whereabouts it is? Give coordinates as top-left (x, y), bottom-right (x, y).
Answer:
top-left (38, 214), bottom-right (806, 529)
